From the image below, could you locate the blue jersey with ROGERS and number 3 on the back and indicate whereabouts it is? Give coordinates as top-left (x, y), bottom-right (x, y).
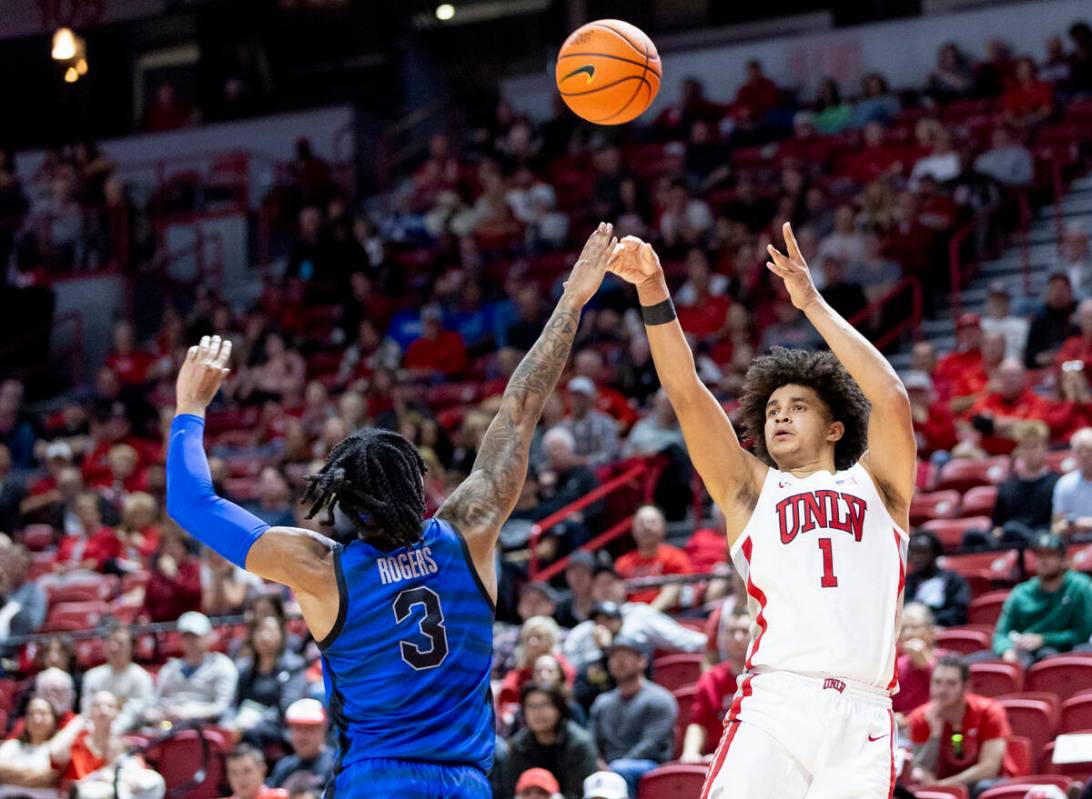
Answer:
top-left (319, 518), bottom-right (495, 782)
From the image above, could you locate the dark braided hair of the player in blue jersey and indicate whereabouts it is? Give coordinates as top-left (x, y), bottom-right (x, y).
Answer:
top-left (302, 428), bottom-right (426, 551)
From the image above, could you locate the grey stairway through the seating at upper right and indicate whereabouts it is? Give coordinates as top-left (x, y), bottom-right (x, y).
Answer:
top-left (890, 175), bottom-right (1092, 371)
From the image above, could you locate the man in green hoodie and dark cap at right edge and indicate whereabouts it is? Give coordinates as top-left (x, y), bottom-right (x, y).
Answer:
top-left (994, 533), bottom-right (1092, 668)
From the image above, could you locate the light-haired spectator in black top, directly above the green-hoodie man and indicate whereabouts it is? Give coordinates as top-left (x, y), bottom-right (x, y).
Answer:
top-left (963, 419), bottom-right (1058, 549)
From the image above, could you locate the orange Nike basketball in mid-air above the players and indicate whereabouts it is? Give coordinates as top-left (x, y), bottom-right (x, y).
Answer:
top-left (555, 20), bottom-right (662, 124)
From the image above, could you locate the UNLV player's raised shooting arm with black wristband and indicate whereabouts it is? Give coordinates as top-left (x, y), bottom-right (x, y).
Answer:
top-left (609, 236), bottom-right (769, 542)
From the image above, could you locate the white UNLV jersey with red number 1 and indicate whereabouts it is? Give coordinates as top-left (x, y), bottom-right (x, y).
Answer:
top-left (732, 463), bottom-right (907, 692)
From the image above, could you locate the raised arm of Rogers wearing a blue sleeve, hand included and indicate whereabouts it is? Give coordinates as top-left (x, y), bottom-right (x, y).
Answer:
top-left (167, 336), bottom-right (339, 641)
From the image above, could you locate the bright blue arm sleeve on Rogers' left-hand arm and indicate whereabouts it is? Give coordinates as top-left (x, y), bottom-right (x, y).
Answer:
top-left (167, 414), bottom-right (270, 569)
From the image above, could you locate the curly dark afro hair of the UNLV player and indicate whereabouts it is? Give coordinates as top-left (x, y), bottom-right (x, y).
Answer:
top-left (739, 347), bottom-right (871, 470)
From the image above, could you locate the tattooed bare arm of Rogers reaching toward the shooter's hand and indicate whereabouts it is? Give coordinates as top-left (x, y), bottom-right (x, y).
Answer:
top-left (436, 224), bottom-right (616, 597)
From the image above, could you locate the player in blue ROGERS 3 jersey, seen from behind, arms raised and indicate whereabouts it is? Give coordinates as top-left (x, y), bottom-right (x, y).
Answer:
top-left (167, 225), bottom-right (616, 799)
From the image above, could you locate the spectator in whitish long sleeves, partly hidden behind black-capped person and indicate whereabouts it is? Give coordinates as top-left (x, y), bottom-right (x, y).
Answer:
top-left (561, 567), bottom-right (705, 669)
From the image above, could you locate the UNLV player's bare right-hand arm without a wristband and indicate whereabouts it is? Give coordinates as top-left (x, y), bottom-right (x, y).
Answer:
top-left (767, 222), bottom-right (917, 527)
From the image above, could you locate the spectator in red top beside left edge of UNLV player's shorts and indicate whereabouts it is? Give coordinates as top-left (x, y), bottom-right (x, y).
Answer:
top-left (679, 608), bottom-right (751, 763)
